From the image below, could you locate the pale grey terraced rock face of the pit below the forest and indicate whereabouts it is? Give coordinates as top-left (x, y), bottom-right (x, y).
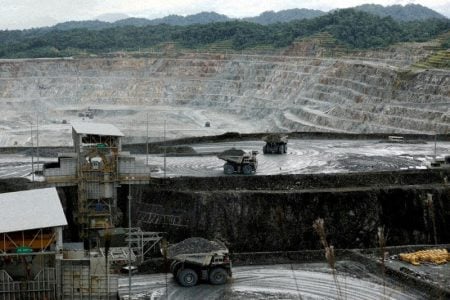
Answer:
top-left (0, 54), bottom-right (450, 145)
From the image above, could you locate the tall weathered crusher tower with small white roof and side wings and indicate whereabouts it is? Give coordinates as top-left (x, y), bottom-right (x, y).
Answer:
top-left (43, 122), bottom-right (150, 241)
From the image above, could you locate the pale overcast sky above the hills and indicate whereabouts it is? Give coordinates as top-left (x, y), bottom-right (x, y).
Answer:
top-left (0, 0), bottom-right (450, 29)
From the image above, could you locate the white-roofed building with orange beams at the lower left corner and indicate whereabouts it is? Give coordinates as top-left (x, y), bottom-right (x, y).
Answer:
top-left (0, 188), bottom-right (67, 299)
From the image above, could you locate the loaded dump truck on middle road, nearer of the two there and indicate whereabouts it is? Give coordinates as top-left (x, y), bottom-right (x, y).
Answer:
top-left (217, 148), bottom-right (258, 175)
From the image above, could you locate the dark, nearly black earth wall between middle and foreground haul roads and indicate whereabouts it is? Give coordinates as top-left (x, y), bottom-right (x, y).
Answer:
top-left (121, 170), bottom-right (450, 252)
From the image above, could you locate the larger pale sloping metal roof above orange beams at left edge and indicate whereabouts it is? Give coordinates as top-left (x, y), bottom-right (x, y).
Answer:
top-left (0, 188), bottom-right (67, 233)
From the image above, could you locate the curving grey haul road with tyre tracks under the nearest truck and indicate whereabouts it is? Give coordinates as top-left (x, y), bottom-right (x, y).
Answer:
top-left (119, 261), bottom-right (425, 300)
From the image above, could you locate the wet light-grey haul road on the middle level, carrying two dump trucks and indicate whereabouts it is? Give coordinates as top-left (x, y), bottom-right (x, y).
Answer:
top-left (0, 139), bottom-right (444, 178)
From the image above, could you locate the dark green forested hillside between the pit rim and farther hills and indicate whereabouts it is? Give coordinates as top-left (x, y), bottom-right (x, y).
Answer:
top-left (0, 9), bottom-right (450, 58)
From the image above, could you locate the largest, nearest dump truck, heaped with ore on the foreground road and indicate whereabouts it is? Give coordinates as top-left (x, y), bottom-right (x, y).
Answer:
top-left (167, 238), bottom-right (232, 287)
